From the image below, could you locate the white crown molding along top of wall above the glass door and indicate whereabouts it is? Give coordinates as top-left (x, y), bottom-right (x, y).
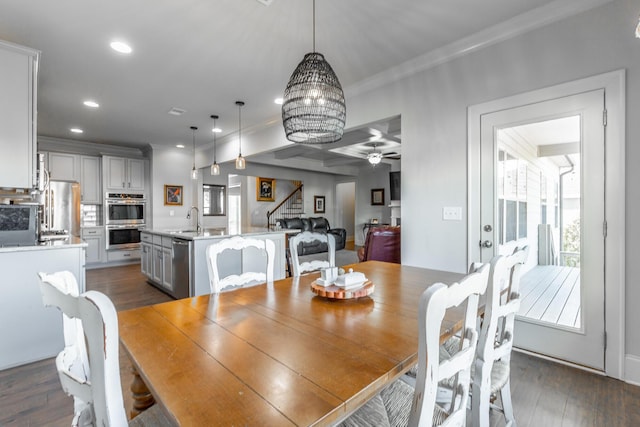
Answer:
top-left (345, 0), bottom-right (613, 96)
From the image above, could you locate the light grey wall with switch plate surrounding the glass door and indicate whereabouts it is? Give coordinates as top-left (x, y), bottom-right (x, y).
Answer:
top-left (348, 0), bottom-right (640, 364)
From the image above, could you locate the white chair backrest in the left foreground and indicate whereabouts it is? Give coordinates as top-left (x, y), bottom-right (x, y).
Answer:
top-left (39, 271), bottom-right (127, 426)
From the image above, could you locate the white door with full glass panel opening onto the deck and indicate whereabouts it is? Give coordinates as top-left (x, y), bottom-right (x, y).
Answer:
top-left (480, 90), bottom-right (604, 370)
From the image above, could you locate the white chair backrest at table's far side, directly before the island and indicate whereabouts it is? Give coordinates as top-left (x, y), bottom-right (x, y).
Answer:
top-left (207, 236), bottom-right (276, 294)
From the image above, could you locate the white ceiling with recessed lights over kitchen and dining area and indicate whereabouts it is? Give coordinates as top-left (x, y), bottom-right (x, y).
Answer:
top-left (0, 0), bottom-right (583, 169)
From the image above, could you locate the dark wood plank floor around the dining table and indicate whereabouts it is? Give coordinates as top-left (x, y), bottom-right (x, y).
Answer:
top-left (0, 265), bottom-right (640, 427)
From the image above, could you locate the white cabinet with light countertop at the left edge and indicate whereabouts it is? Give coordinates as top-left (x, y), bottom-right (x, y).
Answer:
top-left (0, 236), bottom-right (87, 370)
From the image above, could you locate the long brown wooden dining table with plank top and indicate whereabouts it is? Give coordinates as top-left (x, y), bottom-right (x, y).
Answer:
top-left (118, 261), bottom-right (463, 426)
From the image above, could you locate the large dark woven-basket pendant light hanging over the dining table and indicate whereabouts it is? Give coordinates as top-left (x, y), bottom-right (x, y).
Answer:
top-left (282, 0), bottom-right (347, 144)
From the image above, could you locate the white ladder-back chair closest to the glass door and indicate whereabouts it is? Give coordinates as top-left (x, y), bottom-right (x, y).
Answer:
top-left (471, 246), bottom-right (529, 427)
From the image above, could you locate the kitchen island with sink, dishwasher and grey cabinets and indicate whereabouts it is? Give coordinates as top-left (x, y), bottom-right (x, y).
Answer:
top-left (140, 229), bottom-right (297, 298)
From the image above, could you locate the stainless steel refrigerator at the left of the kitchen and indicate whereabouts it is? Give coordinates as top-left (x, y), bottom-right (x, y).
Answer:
top-left (42, 181), bottom-right (80, 237)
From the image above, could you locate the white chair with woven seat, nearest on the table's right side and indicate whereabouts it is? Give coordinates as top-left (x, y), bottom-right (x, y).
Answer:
top-left (342, 265), bottom-right (489, 427)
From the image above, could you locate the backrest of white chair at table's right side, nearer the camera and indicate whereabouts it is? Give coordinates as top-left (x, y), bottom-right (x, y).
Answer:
top-left (409, 265), bottom-right (489, 426)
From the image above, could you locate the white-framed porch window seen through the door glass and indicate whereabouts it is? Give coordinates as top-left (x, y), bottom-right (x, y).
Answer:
top-left (497, 150), bottom-right (529, 245)
